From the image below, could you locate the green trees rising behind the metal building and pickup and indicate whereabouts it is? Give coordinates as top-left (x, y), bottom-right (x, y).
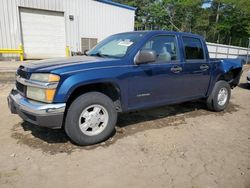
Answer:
top-left (114, 0), bottom-right (250, 47)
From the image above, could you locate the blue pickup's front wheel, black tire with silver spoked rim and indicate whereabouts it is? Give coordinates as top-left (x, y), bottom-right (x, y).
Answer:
top-left (65, 92), bottom-right (117, 146)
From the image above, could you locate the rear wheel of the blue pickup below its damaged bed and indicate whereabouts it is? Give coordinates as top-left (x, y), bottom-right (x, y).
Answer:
top-left (206, 80), bottom-right (231, 112)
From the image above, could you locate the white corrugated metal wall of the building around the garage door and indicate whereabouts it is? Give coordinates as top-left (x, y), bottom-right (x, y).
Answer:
top-left (0, 0), bottom-right (135, 58)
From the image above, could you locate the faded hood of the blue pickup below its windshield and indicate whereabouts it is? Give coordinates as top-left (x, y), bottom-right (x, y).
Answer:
top-left (23, 56), bottom-right (121, 72)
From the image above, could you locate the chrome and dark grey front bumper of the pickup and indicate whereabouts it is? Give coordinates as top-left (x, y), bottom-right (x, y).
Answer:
top-left (7, 89), bottom-right (66, 128)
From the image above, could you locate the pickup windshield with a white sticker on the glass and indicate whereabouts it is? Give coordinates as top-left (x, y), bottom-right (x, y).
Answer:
top-left (87, 33), bottom-right (144, 58)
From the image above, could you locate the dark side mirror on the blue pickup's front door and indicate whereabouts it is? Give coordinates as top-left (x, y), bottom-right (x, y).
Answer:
top-left (135, 50), bottom-right (156, 65)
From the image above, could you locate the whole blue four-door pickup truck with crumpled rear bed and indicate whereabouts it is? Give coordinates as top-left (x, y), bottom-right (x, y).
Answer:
top-left (8, 31), bottom-right (242, 145)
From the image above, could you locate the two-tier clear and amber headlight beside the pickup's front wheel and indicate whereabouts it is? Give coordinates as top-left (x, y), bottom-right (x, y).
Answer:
top-left (26, 73), bottom-right (60, 103)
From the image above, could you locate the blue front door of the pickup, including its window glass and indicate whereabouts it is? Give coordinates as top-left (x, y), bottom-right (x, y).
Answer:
top-left (128, 35), bottom-right (186, 109)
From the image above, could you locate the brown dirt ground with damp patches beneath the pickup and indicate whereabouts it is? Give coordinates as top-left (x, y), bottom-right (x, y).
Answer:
top-left (0, 68), bottom-right (250, 188)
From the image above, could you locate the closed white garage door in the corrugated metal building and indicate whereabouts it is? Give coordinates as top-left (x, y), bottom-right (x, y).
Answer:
top-left (20, 8), bottom-right (66, 59)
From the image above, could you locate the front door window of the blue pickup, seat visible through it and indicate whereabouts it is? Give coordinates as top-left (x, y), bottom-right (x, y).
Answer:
top-left (142, 35), bottom-right (179, 63)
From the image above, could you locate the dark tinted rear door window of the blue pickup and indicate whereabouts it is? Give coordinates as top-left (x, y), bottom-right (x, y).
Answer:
top-left (182, 37), bottom-right (204, 60)
